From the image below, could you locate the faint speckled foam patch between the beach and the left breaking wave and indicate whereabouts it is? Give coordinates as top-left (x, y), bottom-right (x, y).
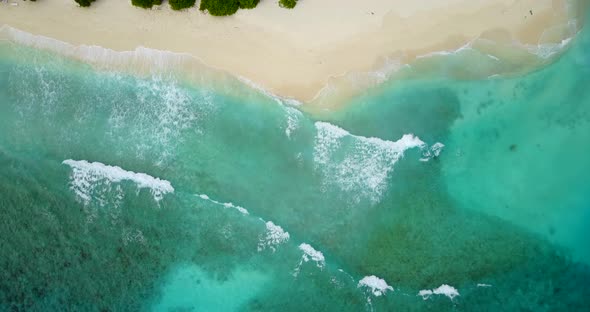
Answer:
top-left (119, 75), bottom-right (209, 165)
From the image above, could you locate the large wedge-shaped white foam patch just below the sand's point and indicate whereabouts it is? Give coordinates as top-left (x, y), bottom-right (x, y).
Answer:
top-left (314, 122), bottom-right (428, 202)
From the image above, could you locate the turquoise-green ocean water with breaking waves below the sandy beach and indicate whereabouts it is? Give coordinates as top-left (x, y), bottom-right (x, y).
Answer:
top-left (0, 11), bottom-right (590, 311)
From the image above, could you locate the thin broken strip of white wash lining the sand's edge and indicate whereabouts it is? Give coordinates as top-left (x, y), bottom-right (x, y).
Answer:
top-left (0, 20), bottom-right (578, 118)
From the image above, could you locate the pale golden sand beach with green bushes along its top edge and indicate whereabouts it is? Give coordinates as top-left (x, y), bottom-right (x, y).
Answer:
top-left (0, 0), bottom-right (575, 106)
